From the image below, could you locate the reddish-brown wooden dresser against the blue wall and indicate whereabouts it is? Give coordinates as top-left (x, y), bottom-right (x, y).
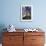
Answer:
top-left (2, 32), bottom-right (44, 46)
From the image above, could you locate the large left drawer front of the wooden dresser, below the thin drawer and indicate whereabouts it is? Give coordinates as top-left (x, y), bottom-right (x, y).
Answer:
top-left (3, 36), bottom-right (23, 46)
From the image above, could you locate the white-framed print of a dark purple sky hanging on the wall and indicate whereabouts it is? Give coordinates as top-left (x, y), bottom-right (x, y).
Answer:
top-left (21, 5), bottom-right (33, 21)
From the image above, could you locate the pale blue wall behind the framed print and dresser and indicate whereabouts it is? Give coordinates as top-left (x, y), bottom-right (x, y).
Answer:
top-left (0, 0), bottom-right (46, 31)
